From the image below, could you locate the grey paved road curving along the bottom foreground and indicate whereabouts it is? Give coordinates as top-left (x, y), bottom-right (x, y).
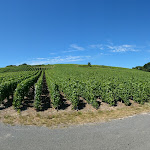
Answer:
top-left (0, 114), bottom-right (150, 150)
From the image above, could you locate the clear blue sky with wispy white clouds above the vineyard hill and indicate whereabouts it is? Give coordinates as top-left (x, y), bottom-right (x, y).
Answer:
top-left (0, 0), bottom-right (150, 68)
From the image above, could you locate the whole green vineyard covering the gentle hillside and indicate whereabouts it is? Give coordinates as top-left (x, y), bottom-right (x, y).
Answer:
top-left (0, 64), bottom-right (150, 111)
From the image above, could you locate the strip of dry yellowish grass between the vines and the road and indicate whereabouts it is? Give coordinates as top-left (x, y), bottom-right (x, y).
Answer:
top-left (0, 103), bottom-right (150, 128)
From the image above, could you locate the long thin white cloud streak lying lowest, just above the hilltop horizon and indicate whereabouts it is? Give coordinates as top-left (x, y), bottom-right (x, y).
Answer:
top-left (28, 56), bottom-right (90, 65)
